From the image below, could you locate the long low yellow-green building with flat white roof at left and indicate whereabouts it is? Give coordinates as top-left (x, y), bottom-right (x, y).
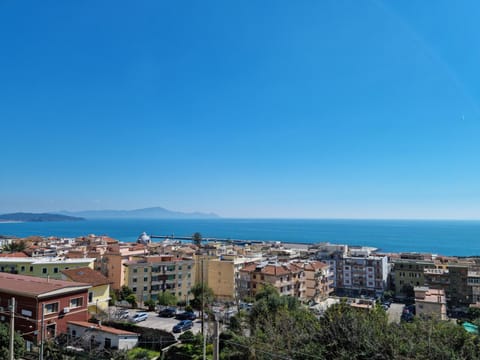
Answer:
top-left (0, 257), bottom-right (95, 280)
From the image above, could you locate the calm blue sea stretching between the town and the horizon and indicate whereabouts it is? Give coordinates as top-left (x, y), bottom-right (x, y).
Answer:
top-left (0, 219), bottom-right (480, 256)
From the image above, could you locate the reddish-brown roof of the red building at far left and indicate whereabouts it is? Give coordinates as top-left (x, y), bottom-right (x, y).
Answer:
top-left (0, 273), bottom-right (89, 297)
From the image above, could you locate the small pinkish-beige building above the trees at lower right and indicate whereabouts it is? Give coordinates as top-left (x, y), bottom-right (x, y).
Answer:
top-left (414, 286), bottom-right (447, 320)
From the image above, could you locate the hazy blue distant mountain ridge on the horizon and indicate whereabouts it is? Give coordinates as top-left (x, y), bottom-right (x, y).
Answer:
top-left (58, 207), bottom-right (219, 219)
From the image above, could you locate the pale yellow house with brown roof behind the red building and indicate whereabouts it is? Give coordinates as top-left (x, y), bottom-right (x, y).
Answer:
top-left (62, 267), bottom-right (110, 314)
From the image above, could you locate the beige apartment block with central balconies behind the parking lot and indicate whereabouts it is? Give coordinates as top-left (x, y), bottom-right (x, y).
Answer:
top-left (123, 255), bottom-right (195, 303)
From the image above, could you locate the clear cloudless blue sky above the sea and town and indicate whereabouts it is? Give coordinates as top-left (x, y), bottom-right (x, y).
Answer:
top-left (0, 0), bottom-right (480, 219)
